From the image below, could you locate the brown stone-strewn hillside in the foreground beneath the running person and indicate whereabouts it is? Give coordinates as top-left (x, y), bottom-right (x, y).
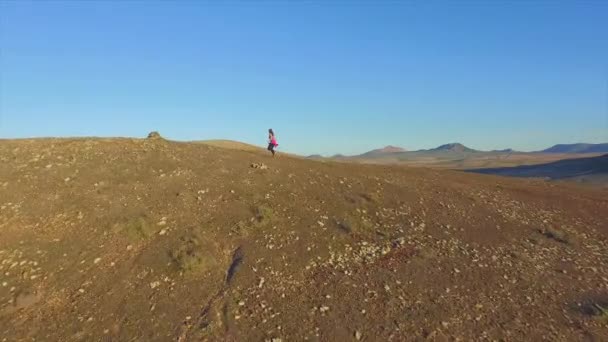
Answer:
top-left (0, 137), bottom-right (608, 342)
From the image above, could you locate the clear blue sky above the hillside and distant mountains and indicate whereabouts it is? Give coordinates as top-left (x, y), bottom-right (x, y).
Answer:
top-left (0, 0), bottom-right (608, 154)
